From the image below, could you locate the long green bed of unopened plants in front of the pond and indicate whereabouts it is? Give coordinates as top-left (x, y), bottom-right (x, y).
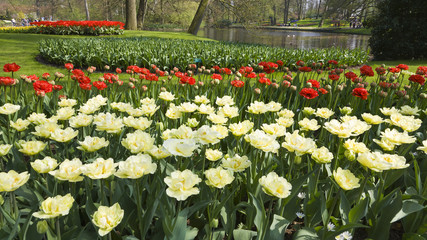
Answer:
top-left (39, 38), bottom-right (369, 70)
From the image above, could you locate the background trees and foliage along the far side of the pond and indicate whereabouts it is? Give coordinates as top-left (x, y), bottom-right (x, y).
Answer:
top-left (0, 0), bottom-right (378, 33)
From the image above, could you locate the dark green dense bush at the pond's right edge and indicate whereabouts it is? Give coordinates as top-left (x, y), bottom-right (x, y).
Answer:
top-left (368, 0), bottom-right (427, 60)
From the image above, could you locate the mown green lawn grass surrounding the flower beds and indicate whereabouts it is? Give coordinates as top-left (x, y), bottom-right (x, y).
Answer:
top-left (0, 31), bottom-right (427, 79)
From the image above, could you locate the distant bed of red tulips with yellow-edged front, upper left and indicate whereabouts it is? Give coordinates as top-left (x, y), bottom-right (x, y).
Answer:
top-left (30, 21), bottom-right (125, 35)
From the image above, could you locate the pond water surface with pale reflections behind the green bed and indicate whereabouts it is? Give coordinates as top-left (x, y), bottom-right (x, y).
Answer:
top-left (197, 28), bottom-right (369, 50)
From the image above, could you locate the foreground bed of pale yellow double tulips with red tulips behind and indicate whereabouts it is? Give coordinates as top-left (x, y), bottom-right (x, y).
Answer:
top-left (0, 60), bottom-right (427, 240)
